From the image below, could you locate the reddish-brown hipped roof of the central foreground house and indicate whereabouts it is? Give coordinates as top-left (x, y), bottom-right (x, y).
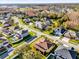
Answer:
top-left (34, 39), bottom-right (55, 52)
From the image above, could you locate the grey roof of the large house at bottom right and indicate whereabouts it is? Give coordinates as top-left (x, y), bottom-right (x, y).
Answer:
top-left (55, 47), bottom-right (76, 59)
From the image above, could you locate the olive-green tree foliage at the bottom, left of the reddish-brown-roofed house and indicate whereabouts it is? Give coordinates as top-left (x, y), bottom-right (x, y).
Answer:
top-left (14, 45), bottom-right (42, 59)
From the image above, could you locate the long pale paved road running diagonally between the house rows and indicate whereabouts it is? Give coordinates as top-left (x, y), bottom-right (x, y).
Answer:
top-left (19, 16), bottom-right (79, 50)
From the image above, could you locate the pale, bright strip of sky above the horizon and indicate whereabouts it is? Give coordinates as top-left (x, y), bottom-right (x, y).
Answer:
top-left (0, 0), bottom-right (79, 4)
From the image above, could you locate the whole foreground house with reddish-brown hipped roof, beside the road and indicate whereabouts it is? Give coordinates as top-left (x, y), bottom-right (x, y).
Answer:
top-left (34, 39), bottom-right (55, 54)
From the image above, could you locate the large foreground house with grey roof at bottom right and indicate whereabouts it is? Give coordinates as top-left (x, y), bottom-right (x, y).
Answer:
top-left (47, 46), bottom-right (77, 59)
